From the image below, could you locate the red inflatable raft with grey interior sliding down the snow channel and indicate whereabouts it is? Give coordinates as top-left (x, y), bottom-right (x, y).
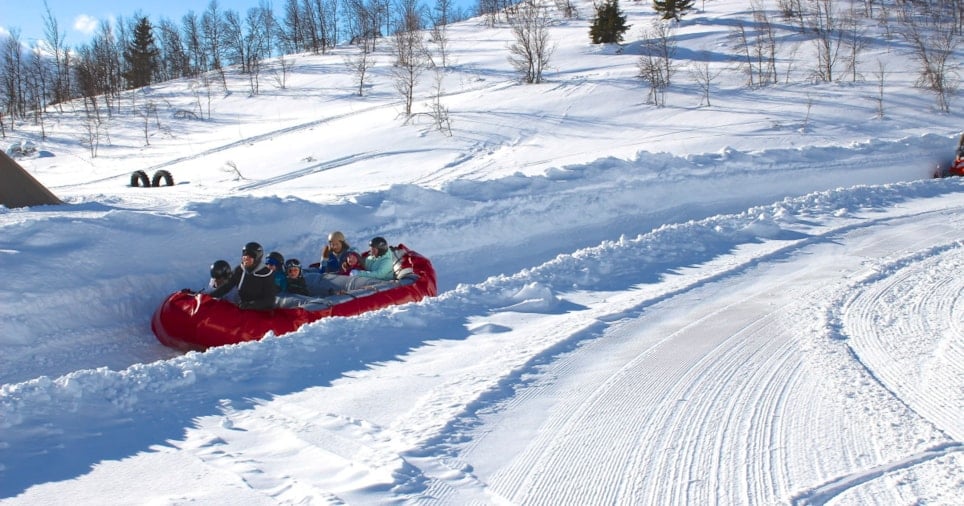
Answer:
top-left (151, 245), bottom-right (438, 351)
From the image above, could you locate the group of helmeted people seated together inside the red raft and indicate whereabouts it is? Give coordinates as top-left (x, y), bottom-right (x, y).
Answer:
top-left (208, 231), bottom-right (404, 311)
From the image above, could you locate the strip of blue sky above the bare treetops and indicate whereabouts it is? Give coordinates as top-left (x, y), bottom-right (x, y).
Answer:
top-left (0, 0), bottom-right (477, 47)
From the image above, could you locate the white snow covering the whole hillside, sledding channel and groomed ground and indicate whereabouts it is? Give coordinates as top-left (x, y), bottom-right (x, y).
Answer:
top-left (0, 0), bottom-right (964, 505)
